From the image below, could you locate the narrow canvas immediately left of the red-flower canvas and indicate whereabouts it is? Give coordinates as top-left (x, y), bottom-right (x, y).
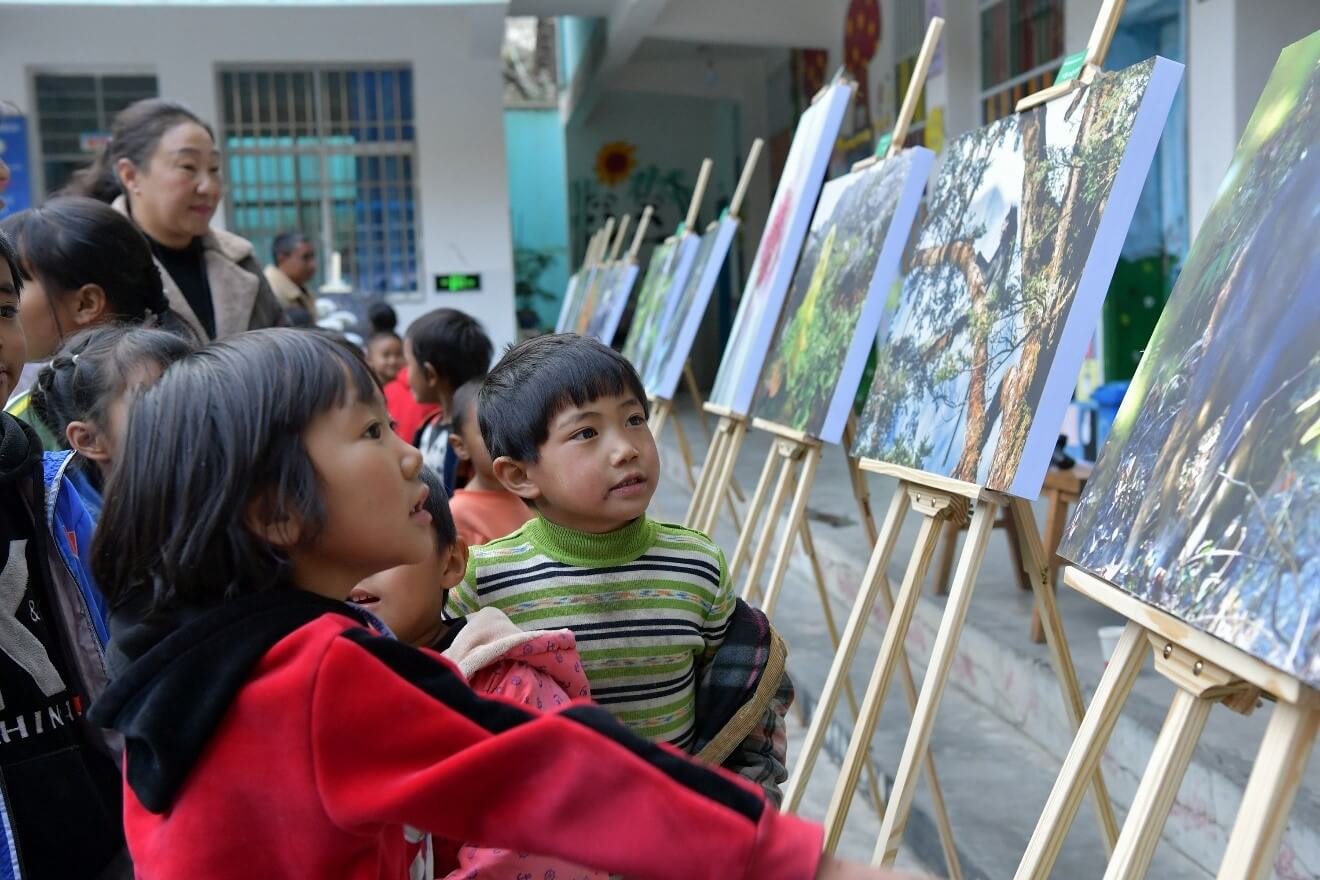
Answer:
top-left (642, 216), bottom-right (738, 400)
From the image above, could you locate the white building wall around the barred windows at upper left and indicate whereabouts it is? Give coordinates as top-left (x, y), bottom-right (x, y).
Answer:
top-left (0, 3), bottom-right (515, 351)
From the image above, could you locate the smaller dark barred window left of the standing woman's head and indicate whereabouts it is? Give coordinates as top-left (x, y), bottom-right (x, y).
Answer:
top-left (33, 73), bottom-right (157, 195)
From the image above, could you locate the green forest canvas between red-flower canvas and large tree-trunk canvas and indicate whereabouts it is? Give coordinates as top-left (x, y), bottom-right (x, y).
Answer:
top-left (751, 148), bottom-right (935, 443)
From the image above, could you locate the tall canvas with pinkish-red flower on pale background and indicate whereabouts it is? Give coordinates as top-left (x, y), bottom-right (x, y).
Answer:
top-left (710, 82), bottom-right (853, 416)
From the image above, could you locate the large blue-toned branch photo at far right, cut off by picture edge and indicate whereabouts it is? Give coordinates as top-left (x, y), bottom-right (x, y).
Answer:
top-left (1060, 33), bottom-right (1320, 687)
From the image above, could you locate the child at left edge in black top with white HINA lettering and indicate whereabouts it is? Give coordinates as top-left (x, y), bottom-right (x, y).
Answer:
top-left (0, 225), bottom-right (132, 877)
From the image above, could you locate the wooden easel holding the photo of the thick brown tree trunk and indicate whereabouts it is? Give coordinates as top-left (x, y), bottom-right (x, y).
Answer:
top-left (784, 0), bottom-right (1123, 865)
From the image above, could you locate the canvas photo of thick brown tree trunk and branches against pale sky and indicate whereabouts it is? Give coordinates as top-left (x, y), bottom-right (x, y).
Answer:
top-left (854, 58), bottom-right (1181, 497)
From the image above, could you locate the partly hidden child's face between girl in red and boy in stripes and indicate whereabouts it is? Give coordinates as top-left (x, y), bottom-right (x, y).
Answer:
top-left (348, 538), bottom-right (467, 645)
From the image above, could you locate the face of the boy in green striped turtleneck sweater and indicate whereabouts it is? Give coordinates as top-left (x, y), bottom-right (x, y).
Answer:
top-left (495, 393), bottom-right (660, 533)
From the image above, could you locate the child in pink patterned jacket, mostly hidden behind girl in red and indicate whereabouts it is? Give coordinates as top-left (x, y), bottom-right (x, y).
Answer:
top-left (348, 467), bottom-right (609, 880)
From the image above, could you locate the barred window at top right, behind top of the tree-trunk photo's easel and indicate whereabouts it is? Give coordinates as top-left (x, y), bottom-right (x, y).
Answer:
top-left (981, 0), bottom-right (1064, 123)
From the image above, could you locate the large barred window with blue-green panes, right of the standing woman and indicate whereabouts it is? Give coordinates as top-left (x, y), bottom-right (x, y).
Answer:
top-left (219, 66), bottom-right (421, 294)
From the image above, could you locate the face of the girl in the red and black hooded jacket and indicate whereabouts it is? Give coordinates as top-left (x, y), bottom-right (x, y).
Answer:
top-left (287, 391), bottom-right (436, 600)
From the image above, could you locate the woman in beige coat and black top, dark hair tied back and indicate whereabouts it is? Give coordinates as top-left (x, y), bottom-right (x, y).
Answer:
top-left (70, 98), bottom-right (281, 339)
